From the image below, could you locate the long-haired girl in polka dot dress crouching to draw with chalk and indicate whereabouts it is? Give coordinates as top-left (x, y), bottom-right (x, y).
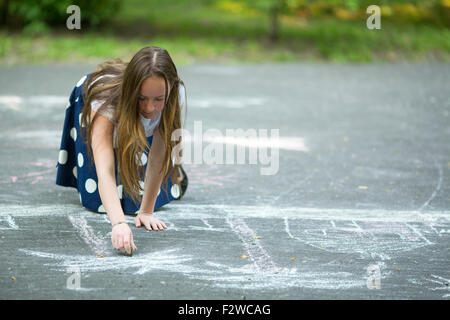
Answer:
top-left (56, 46), bottom-right (188, 254)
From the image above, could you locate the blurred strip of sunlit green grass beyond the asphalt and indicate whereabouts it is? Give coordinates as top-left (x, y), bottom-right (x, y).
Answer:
top-left (0, 0), bottom-right (450, 64)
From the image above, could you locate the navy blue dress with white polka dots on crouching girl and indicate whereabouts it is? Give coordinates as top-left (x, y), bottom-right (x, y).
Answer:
top-left (56, 74), bottom-right (185, 214)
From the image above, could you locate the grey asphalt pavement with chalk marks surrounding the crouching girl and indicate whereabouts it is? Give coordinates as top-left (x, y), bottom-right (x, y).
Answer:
top-left (0, 64), bottom-right (450, 300)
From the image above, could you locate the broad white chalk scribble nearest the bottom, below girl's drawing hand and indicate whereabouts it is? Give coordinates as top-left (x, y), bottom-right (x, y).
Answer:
top-left (19, 249), bottom-right (366, 290)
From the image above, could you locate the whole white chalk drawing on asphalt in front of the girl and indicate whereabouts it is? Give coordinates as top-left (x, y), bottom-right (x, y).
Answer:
top-left (11, 205), bottom-right (448, 289)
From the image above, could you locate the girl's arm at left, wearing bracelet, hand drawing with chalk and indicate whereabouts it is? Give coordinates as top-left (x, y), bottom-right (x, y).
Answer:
top-left (90, 110), bottom-right (137, 252)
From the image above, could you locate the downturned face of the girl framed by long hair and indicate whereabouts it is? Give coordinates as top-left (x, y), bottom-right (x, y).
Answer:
top-left (139, 76), bottom-right (170, 119)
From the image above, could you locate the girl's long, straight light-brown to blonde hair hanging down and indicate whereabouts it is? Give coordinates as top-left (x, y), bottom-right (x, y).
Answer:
top-left (81, 46), bottom-right (184, 203)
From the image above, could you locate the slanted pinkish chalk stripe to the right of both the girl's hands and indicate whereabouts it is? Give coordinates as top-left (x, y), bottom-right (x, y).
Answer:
top-left (226, 217), bottom-right (282, 273)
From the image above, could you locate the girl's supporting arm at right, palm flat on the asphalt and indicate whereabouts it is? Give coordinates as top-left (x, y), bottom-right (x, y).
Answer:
top-left (135, 129), bottom-right (167, 230)
